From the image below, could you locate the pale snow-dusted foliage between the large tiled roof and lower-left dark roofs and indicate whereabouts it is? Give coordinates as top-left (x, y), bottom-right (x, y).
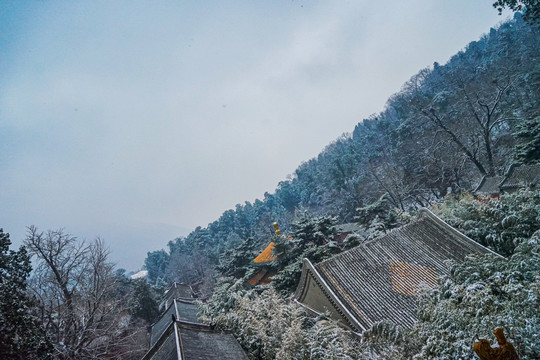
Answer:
top-left (203, 279), bottom-right (358, 360)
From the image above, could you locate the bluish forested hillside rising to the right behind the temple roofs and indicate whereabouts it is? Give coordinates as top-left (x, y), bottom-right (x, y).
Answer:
top-left (145, 13), bottom-right (540, 285)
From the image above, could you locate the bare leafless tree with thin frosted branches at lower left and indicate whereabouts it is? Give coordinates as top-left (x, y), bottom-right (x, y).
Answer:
top-left (25, 227), bottom-right (145, 360)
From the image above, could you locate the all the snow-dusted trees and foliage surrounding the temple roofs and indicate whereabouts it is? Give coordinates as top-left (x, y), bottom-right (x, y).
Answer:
top-left (0, 5), bottom-right (540, 359)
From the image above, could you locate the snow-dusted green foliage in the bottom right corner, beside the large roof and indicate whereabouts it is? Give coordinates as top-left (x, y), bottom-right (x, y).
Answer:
top-left (412, 232), bottom-right (540, 360)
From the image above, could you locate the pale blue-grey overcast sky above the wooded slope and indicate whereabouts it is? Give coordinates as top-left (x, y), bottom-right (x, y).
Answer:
top-left (0, 0), bottom-right (510, 270)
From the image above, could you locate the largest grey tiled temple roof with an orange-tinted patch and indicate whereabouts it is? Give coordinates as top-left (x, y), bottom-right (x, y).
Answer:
top-left (294, 209), bottom-right (493, 332)
